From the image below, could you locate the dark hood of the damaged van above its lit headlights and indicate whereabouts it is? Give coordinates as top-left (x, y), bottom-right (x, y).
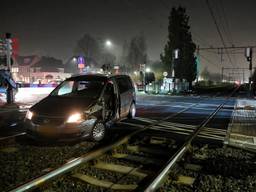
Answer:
top-left (31, 96), bottom-right (97, 116)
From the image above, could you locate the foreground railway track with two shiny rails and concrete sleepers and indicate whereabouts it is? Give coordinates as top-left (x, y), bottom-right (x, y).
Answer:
top-left (6, 92), bottom-right (242, 191)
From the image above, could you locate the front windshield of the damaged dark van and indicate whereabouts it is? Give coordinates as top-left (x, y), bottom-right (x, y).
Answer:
top-left (51, 80), bottom-right (104, 98)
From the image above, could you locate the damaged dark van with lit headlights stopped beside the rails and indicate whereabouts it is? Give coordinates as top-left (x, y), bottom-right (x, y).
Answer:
top-left (24, 74), bottom-right (136, 141)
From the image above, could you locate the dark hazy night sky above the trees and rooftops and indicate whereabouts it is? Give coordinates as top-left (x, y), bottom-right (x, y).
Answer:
top-left (0, 0), bottom-right (256, 76)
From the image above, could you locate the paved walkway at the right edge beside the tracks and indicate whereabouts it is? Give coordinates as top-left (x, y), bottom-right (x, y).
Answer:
top-left (225, 99), bottom-right (256, 151)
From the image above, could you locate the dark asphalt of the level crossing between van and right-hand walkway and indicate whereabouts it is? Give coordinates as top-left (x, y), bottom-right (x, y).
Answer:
top-left (137, 96), bottom-right (235, 129)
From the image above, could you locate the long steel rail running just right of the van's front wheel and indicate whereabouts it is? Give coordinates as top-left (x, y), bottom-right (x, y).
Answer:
top-left (9, 101), bottom-right (204, 192)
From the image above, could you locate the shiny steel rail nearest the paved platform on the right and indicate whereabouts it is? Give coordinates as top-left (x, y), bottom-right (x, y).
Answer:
top-left (144, 87), bottom-right (239, 192)
